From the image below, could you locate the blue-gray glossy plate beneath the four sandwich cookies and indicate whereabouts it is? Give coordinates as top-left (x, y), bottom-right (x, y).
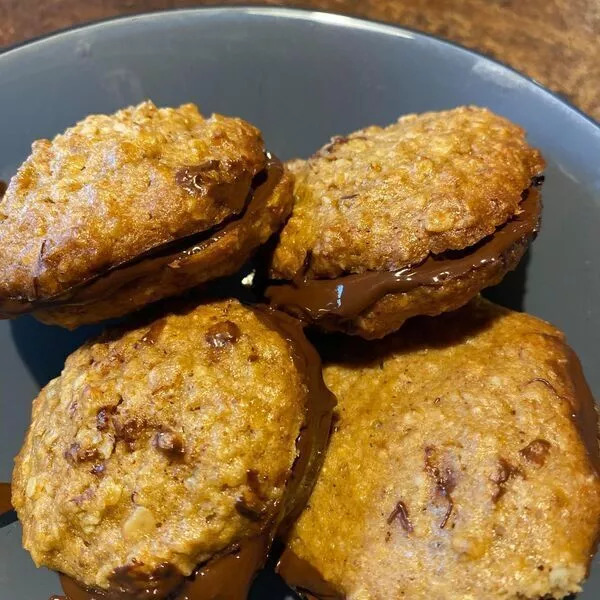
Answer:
top-left (0, 8), bottom-right (600, 600)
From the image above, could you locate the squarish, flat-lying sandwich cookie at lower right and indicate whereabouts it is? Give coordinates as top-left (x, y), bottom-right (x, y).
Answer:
top-left (279, 302), bottom-right (600, 600)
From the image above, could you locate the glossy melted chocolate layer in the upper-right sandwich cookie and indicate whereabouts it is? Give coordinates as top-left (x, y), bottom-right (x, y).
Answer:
top-left (266, 188), bottom-right (540, 322)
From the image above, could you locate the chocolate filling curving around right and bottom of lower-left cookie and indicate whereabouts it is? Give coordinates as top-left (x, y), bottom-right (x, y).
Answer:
top-left (48, 307), bottom-right (335, 600)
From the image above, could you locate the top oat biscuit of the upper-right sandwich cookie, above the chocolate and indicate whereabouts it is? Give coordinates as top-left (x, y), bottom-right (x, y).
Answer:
top-left (271, 107), bottom-right (544, 279)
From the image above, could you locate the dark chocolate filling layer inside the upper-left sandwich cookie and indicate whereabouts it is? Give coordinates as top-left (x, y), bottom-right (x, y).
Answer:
top-left (0, 155), bottom-right (283, 318)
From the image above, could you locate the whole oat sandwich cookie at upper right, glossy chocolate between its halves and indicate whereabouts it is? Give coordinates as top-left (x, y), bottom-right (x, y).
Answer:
top-left (267, 107), bottom-right (544, 338)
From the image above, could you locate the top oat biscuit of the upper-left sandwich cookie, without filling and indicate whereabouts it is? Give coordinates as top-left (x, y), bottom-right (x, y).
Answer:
top-left (0, 102), bottom-right (267, 301)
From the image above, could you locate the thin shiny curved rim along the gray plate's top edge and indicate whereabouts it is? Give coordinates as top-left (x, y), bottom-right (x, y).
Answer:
top-left (0, 3), bottom-right (600, 134)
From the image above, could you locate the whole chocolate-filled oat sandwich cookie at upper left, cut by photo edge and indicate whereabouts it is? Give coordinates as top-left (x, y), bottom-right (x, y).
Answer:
top-left (0, 102), bottom-right (292, 328)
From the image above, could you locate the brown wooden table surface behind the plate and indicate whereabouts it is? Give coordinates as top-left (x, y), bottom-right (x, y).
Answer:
top-left (0, 0), bottom-right (600, 121)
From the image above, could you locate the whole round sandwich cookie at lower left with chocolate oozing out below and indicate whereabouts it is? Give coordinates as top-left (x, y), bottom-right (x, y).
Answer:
top-left (13, 300), bottom-right (333, 600)
